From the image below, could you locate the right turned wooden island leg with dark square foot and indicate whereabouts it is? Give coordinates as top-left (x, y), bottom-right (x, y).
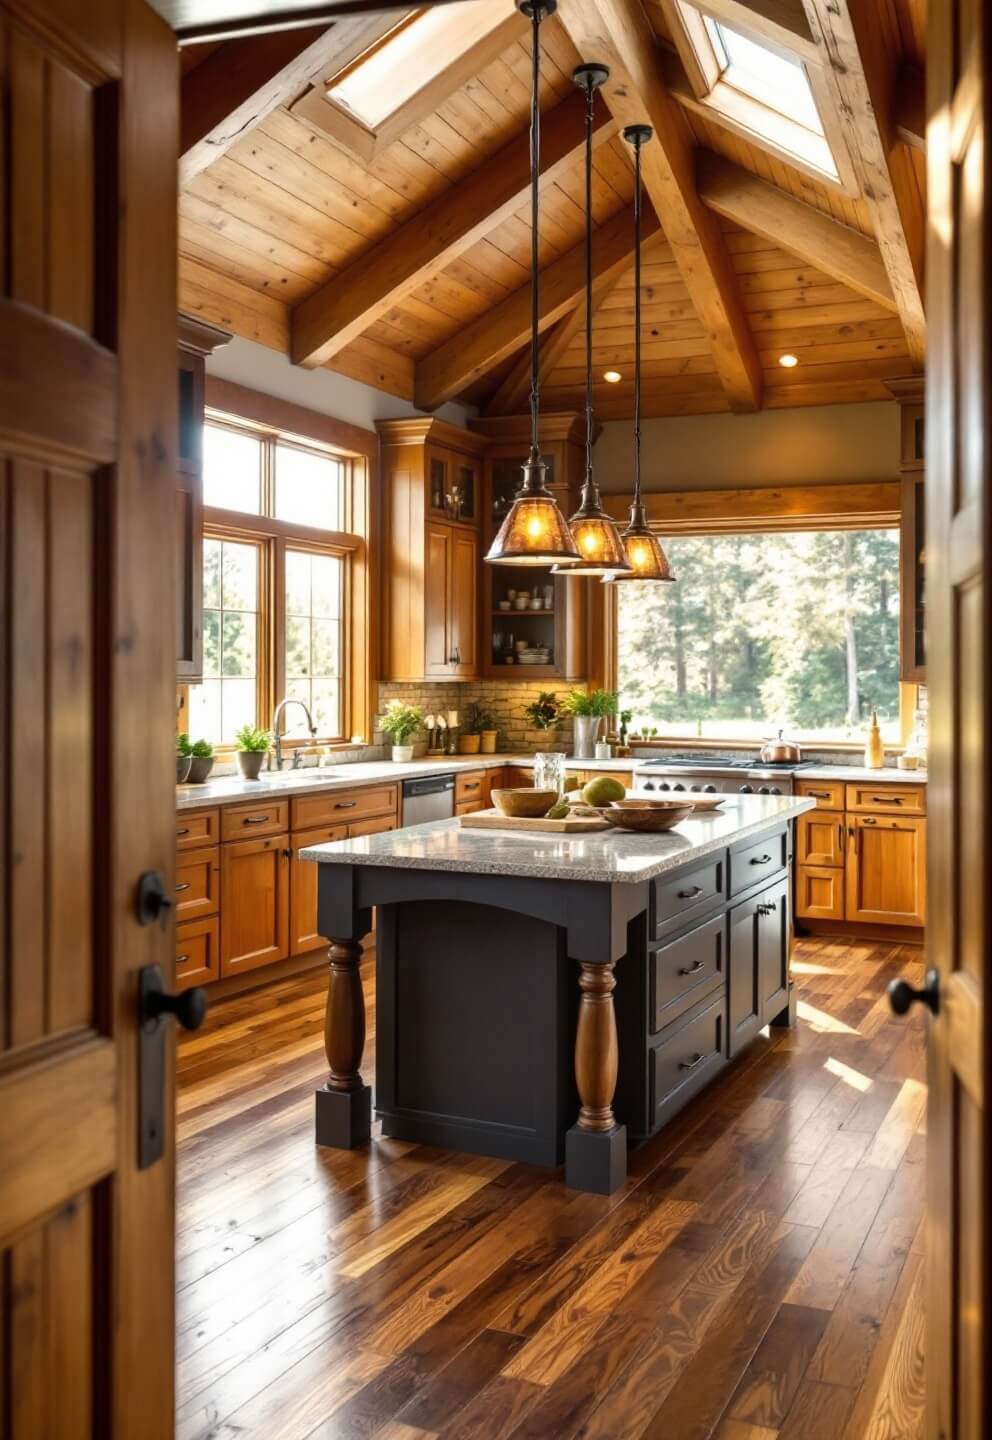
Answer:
top-left (564, 960), bottom-right (626, 1195)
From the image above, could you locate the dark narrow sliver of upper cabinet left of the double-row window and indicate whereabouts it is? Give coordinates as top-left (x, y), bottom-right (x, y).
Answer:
top-left (176, 315), bottom-right (230, 685)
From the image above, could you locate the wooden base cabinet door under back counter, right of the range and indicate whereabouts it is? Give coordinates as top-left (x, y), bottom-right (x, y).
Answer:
top-left (847, 815), bottom-right (927, 926)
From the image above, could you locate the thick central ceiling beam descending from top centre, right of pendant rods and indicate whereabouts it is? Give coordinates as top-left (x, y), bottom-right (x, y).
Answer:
top-left (559, 0), bottom-right (763, 410)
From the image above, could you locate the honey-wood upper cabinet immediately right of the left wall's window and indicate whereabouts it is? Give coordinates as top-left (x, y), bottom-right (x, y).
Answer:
top-left (377, 418), bottom-right (485, 680)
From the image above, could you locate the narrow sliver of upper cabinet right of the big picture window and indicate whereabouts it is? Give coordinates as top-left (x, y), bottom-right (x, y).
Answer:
top-left (888, 376), bottom-right (927, 685)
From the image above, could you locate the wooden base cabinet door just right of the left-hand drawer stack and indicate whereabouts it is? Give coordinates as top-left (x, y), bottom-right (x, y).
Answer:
top-left (220, 835), bottom-right (291, 976)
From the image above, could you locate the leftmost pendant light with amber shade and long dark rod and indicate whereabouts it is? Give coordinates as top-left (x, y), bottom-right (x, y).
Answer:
top-left (485, 0), bottom-right (579, 566)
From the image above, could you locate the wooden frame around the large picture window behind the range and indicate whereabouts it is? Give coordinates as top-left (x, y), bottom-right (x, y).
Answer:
top-left (589, 481), bottom-right (917, 755)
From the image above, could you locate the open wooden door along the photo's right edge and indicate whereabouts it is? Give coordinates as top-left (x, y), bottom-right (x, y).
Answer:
top-left (926, 0), bottom-right (992, 1440)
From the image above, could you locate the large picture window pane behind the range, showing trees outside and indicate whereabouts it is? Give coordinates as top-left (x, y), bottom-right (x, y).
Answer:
top-left (616, 528), bottom-right (900, 742)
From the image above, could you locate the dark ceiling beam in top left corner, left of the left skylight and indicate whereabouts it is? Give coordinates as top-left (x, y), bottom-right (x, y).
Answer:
top-left (179, 13), bottom-right (396, 190)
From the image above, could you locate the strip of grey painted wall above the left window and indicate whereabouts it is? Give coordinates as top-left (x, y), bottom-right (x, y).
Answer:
top-left (207, 336), bottom-right (474, 431)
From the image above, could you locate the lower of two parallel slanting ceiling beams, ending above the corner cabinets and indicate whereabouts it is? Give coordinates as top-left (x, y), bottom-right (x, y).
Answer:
top-left (413, 200), bottom-right (658, 410)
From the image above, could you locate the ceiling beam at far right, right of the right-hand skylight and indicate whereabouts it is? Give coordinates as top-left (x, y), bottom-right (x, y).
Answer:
top-left (803, 0), bottom-right (927, 370)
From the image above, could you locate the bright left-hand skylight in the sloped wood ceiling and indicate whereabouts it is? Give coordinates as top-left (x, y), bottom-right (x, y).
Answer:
top-left (327, 0), bottom-right (514, 131)
